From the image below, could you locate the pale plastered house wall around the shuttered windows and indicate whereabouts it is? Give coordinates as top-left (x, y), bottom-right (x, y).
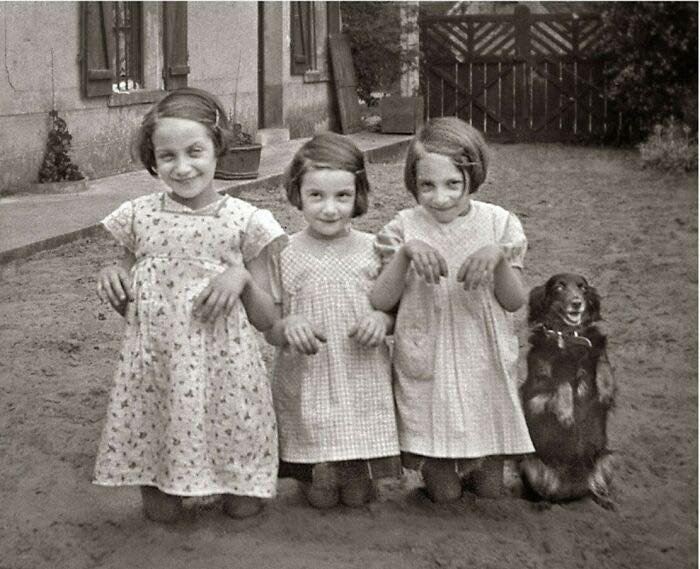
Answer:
top-left (0, 1), bottom-right (340, 192)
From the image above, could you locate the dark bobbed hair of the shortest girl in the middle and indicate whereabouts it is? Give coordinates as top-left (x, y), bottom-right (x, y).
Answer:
top-left (284, 132), bottom-right (370, 217)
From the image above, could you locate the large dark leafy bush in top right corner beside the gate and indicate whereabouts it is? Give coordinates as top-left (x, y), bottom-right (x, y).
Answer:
top-left (601, 2), bottom-right (698, 142)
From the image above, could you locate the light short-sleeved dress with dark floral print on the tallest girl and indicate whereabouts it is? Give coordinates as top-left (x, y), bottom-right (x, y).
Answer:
top-left (94, 193), bottom-right (286, 497)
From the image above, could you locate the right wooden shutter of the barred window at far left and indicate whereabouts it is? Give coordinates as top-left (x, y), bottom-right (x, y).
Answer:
top-left (163, 2), bottom-right (190, 91)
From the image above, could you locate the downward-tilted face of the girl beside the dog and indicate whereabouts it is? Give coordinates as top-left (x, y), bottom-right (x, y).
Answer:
top-left (416, 152), bottom-right (470, 223)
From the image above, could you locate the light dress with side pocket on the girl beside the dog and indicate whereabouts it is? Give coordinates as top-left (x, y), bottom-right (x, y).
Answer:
top-left (377, 200), bottom-right (534, 458)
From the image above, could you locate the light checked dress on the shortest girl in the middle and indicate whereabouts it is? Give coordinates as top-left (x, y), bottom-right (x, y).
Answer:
top-left (272, 230), bottom-right (399, 465)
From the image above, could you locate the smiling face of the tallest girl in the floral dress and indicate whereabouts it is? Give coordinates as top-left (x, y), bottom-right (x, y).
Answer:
top-left (153, 117), bottom-right (219, 209)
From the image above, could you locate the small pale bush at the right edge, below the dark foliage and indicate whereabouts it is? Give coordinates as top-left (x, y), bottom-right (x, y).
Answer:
top-left (639, 119), bottom-right (698, 172)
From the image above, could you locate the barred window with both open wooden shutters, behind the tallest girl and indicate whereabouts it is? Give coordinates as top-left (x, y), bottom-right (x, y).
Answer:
top-left (80, 2), bottom-right (189, 97)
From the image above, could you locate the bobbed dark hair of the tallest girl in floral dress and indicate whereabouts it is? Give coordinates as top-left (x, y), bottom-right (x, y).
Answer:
top-left (134, 87), bottom-right (233, 176)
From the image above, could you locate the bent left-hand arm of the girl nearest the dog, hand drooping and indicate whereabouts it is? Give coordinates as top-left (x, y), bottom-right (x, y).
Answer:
top-left (369, 240), bottom-right (447, 312)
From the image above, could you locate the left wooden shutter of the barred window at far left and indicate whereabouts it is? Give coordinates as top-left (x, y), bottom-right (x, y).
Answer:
top-left (80, 2), bottom-right (116, 97)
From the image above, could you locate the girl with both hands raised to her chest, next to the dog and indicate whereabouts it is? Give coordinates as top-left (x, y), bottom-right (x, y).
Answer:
top-left (370, 118), bottom-right (534, 502)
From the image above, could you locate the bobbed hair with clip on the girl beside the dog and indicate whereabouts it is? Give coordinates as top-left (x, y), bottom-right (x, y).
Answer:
top-left (404, 117), bottom-right (489, 199)
